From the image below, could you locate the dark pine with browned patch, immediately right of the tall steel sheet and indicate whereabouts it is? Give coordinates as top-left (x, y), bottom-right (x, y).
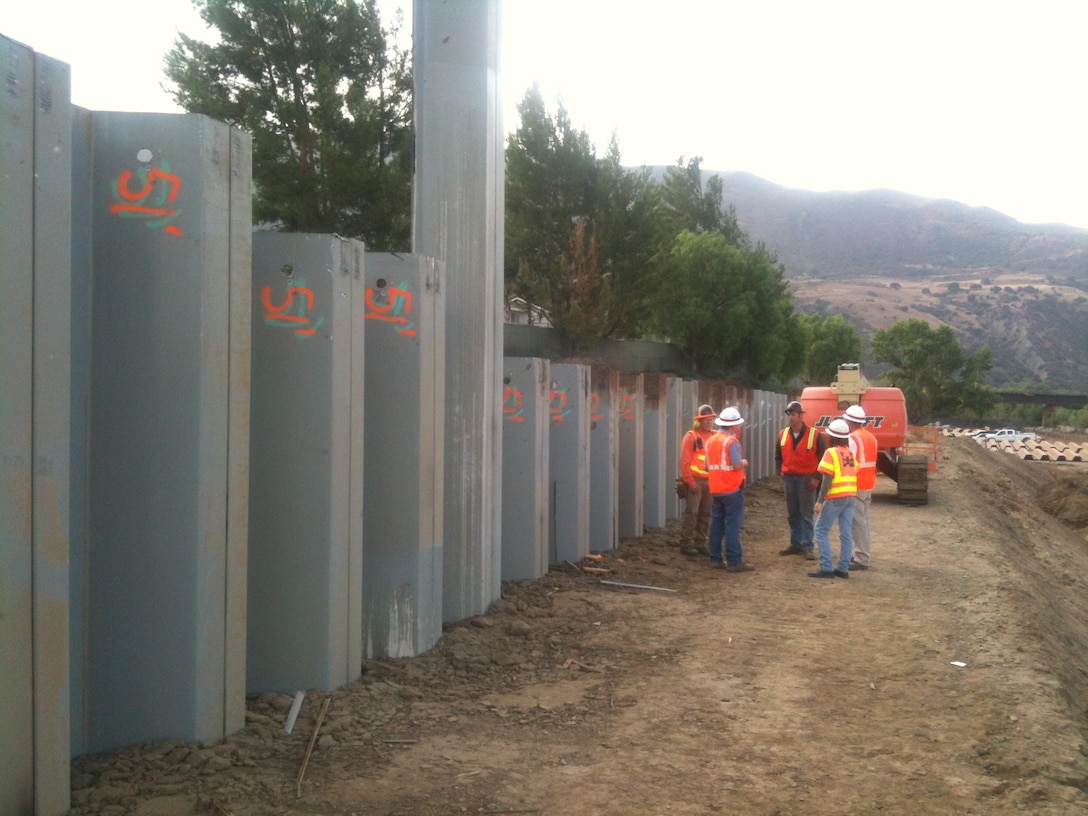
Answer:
top-left (504, 87), bottom-right (657, 341)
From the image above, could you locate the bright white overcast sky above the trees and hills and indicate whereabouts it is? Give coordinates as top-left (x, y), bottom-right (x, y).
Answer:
top-left (0, 0), bottom-right (1088, 227)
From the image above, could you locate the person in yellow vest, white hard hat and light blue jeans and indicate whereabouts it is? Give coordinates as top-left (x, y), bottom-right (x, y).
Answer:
top-left (808, 419), bottom-right (857, 578)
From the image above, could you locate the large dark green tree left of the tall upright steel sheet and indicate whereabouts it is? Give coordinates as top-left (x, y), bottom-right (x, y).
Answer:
top-left (165, 0), bottom-right (413, 250)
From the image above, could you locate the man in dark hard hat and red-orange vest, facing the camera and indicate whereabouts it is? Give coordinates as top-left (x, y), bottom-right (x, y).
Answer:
top-left (775, 399), bottom-right (827, 561)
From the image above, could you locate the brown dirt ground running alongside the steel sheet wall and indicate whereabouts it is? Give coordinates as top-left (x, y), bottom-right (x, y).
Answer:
top-left (72, 438), bottom-right (1088, 816)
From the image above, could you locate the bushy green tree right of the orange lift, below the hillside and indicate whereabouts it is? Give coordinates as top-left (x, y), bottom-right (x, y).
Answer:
top-left (870, 319), bottom-right (996, 422)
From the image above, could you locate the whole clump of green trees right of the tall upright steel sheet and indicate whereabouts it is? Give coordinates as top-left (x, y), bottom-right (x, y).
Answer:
top-left (505, 94), bottom-right (805, 382)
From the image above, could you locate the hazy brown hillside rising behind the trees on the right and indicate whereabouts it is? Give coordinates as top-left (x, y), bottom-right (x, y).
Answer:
top-left (705, 171), bottom-right (1088, 394)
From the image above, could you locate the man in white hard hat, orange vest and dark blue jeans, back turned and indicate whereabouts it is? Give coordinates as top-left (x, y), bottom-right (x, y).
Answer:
top-left (706, 408), bottom-right (755, 572)
